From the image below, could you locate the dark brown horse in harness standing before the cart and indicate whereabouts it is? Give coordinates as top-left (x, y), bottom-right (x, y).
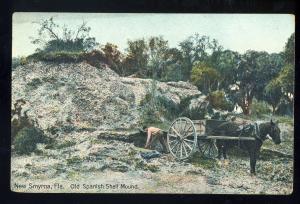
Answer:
top-left (212, 120), bottom-right (281, 174)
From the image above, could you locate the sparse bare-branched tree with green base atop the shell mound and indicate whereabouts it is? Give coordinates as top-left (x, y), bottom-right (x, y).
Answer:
top-left (32, 17), bottom-right (98, 52)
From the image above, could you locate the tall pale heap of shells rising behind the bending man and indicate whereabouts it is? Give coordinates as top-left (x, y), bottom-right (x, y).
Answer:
top-left (12, 62), bottom-right (206, 134)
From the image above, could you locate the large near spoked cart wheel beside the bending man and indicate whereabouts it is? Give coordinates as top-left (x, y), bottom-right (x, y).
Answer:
top-left (167, 117), bottom-right (197, 160)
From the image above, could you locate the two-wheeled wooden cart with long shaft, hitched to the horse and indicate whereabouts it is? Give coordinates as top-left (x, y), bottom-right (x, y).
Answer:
top-left (167, 117), bottom-right (255, 160)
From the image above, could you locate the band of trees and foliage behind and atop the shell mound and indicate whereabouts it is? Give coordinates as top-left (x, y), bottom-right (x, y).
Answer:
top-left (23, 22), bottom-right (295, 120)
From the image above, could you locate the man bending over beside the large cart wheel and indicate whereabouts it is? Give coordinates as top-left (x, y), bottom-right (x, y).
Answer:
top-left (143, 126), bottom-right (168, 152)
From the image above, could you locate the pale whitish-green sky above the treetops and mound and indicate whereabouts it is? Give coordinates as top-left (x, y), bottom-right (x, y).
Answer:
top-left (12, 12), bottom-right (295, 57)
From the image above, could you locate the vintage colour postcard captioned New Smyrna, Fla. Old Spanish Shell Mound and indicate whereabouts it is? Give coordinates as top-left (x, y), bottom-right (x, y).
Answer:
top-left (11, 12), bottom-right (295, 195)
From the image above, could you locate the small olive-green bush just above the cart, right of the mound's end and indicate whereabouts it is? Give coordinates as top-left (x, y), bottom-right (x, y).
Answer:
top-left (208, 91), bottom-right (234, 111)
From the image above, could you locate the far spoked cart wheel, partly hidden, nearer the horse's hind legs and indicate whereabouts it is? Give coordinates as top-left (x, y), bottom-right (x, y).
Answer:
top-left (198, 136), bottom-right (218, 159)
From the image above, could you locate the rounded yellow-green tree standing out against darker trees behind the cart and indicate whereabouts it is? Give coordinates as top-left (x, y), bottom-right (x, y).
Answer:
top-left (191, 63), bottom-right (220, 94)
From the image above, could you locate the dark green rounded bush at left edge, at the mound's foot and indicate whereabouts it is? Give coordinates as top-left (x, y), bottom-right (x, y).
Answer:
top-left (13, 127), bottom-right (47, 154)
